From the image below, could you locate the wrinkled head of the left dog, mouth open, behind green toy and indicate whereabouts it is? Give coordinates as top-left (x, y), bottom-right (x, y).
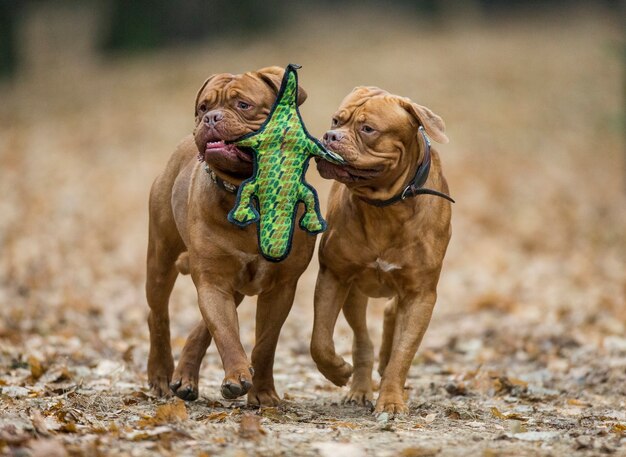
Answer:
top-left (194, 67), bottom-right (306, 181)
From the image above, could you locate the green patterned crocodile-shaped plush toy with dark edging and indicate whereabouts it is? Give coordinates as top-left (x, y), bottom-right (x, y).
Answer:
top-left (228, 64), bottom-right (345, 262)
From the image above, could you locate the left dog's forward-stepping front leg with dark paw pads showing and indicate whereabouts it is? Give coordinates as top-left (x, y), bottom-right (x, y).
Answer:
top-left (194, 282), bottom-right (253, 400)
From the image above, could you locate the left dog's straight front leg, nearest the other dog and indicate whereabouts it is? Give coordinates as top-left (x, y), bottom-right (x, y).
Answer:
top-left (248, 280), bottom-right (297, 406)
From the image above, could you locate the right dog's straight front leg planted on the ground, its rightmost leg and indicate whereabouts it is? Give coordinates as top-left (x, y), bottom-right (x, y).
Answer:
top-left (375, 293), bottom-right (437, 415)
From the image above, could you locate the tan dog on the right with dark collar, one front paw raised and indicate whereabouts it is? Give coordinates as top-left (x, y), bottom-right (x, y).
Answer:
top-left (311, 87), bottom-right (451, 414)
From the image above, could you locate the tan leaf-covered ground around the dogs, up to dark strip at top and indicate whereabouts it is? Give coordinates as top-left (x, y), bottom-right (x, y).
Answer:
top-left (0, 5), bottom-right (626, 457)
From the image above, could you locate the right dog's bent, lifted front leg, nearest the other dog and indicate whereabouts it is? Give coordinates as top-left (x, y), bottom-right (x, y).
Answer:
top-left (311, 266), bottom-right (352, 386)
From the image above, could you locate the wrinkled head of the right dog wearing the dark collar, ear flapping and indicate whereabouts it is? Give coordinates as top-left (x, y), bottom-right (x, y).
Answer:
top-left (317, 87), bottom-right (448, 188)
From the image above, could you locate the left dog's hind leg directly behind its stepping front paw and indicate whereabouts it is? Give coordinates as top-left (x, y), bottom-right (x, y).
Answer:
top-left (170, 292), bottom-right (243, 401)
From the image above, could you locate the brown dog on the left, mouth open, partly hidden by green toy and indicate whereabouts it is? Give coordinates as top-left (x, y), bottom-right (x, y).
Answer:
top-left (146, 67), bottom-right (315, 405)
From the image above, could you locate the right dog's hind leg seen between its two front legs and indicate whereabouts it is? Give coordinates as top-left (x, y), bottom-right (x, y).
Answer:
top-left (343, 287), bottom-right (374, 409)
